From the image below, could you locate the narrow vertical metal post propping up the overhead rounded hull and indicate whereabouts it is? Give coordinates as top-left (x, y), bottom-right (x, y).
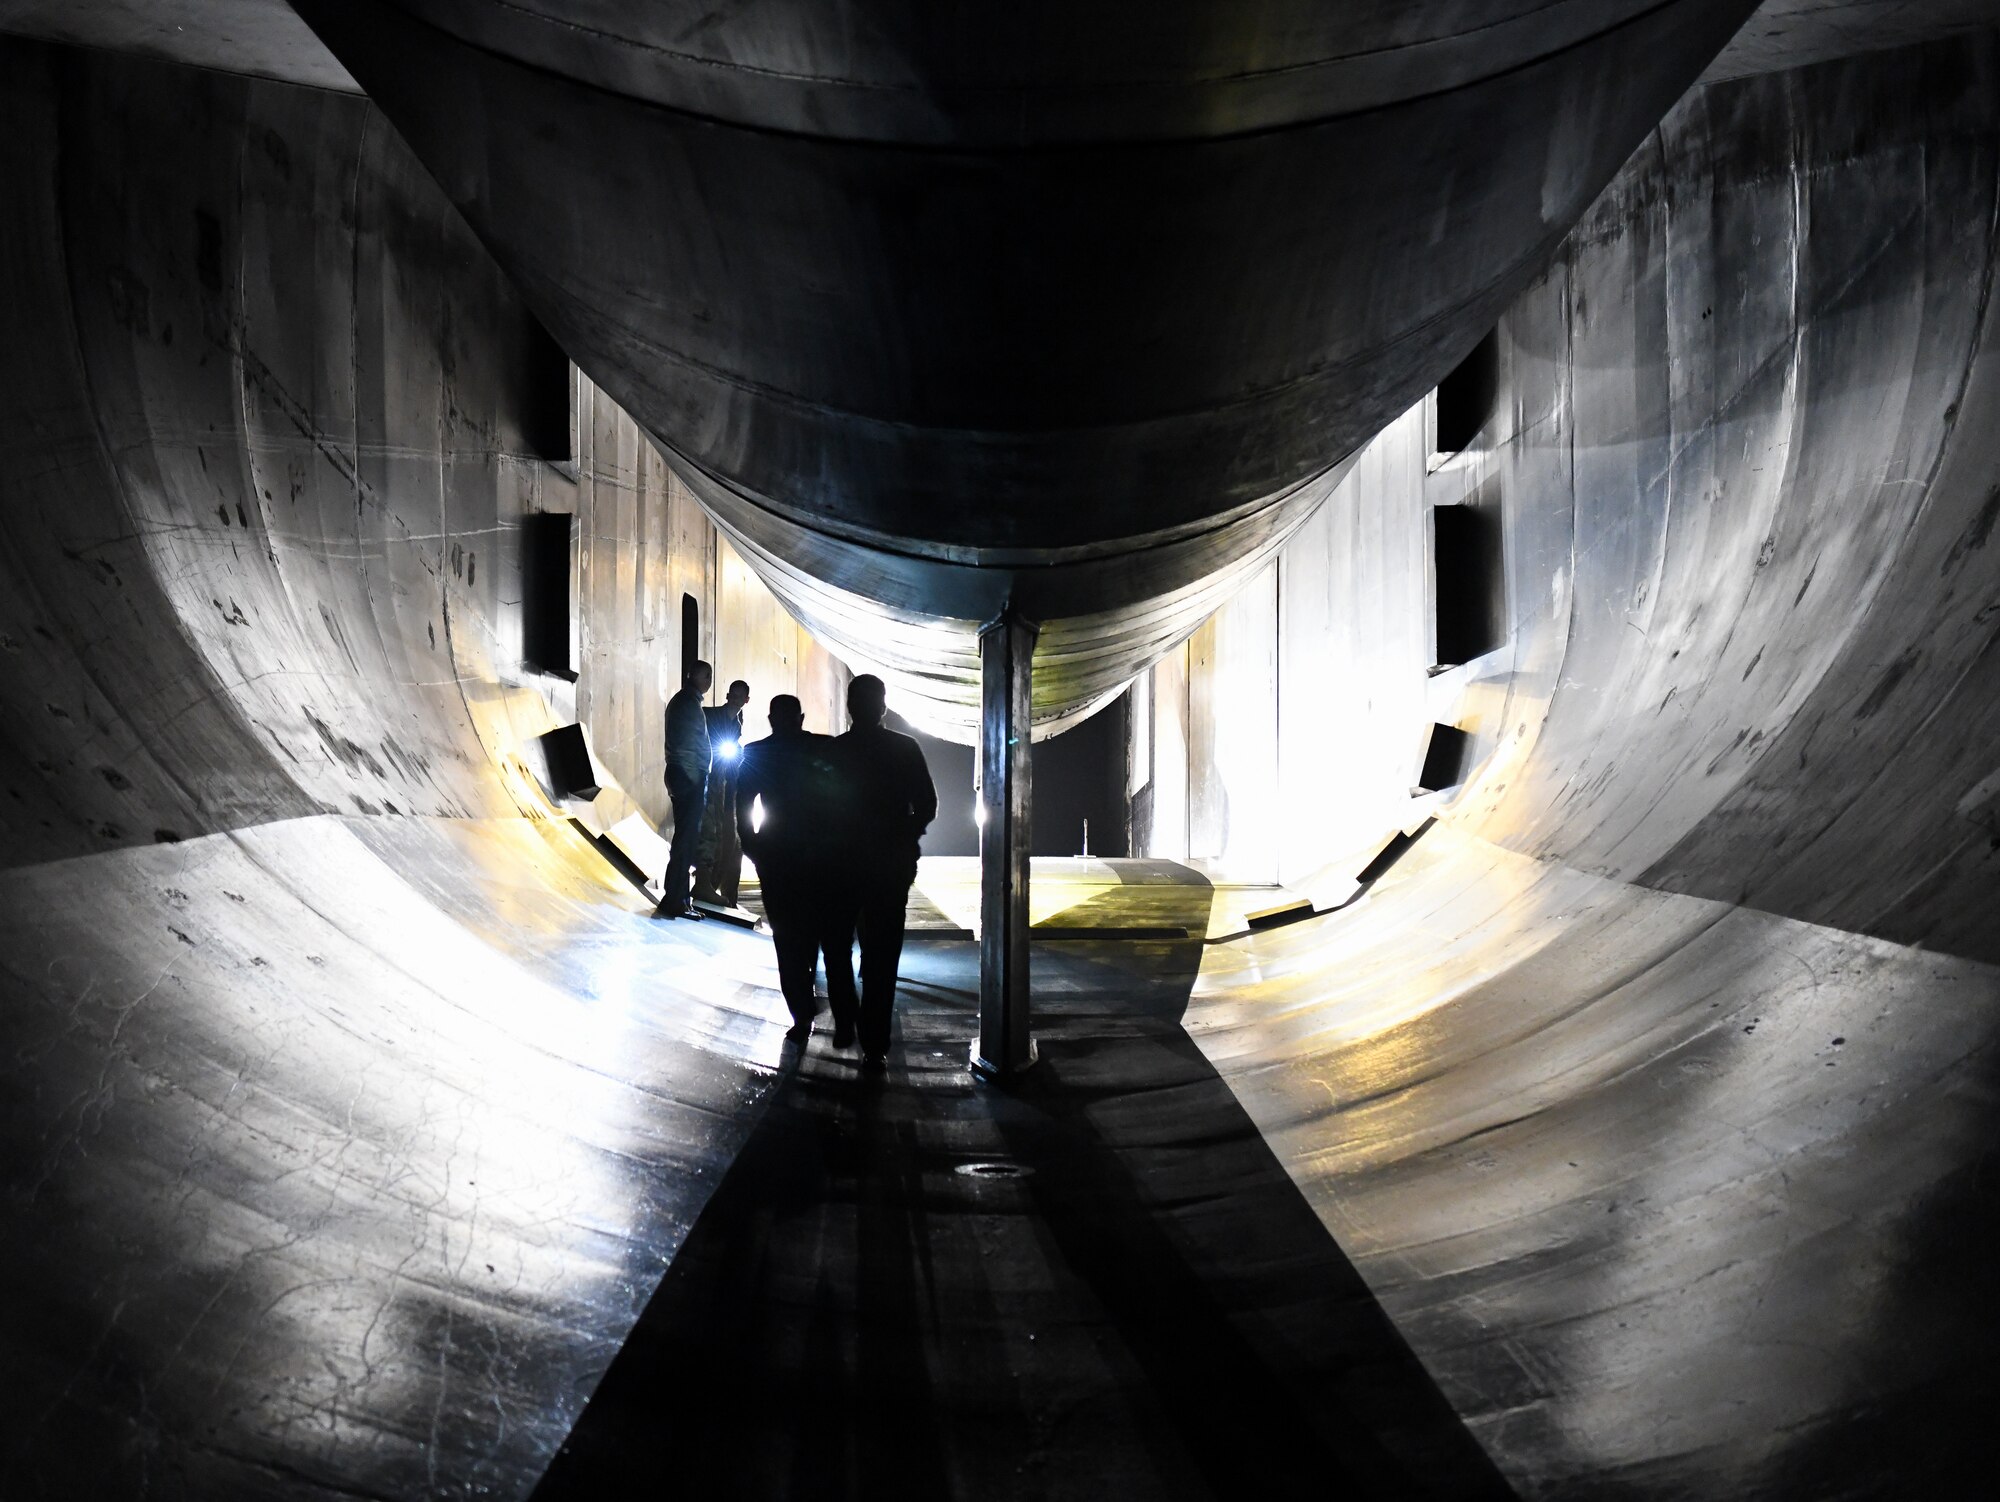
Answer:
top-left (972, 606), bottom-right (1040, 1080)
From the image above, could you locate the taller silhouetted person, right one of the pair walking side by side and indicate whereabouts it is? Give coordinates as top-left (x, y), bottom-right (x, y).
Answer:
top-left (826, 674), bottom-right (938, 1068)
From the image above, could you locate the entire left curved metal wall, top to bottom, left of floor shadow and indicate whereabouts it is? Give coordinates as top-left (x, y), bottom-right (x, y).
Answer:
top-left (0, 38), bottom-right (838, 1500)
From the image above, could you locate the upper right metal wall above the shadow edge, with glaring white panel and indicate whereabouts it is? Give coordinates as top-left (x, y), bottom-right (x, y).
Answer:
top-left (1150, 38), bottom-right (2000, 958)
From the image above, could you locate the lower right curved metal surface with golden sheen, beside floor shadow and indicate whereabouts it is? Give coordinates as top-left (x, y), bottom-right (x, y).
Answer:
top-left (1188, 826), bottom-right (2000, 1498)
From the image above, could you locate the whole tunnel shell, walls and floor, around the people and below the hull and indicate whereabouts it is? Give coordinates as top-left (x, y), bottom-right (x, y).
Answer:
top-left (0, 6), bottom-right (2000, 1498)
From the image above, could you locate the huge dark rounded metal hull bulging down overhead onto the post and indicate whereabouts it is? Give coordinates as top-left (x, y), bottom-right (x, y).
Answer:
top-left (270, 0), bottom-right (1750, 728)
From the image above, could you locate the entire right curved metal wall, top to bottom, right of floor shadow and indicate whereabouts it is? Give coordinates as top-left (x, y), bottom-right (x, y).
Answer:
top-left (1150, 36), bottom-right (2000, 1498)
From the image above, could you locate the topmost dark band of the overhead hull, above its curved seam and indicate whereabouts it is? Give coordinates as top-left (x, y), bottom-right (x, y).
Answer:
top-left (274, 0), bottom-right (1658, 146)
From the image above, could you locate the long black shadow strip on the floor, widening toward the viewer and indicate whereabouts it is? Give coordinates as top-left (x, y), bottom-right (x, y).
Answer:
top-left (536, 862), bottom-right (1510, 1502)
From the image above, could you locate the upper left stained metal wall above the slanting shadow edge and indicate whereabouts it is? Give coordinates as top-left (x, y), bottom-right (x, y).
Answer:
top-left (0, 42), bottom-right (838, 862)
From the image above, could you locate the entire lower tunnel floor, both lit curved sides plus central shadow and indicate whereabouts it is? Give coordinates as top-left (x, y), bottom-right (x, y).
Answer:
top-left (0, 818), bottom-right (2000, 1502)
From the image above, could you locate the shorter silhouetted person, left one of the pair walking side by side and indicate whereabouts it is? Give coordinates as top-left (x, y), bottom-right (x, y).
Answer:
top-left (736, 694), bottom-right (854, 1040)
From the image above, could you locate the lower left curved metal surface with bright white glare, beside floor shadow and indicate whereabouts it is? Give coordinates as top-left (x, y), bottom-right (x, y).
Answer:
top-left (0, 816), bottom-right (786, 1502)
